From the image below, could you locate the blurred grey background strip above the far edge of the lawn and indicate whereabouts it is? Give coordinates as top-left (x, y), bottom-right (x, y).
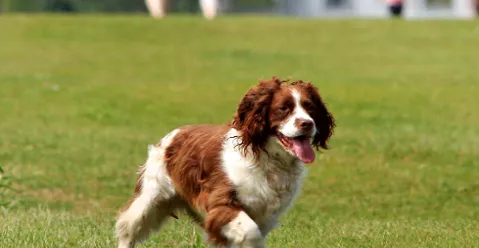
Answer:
top-left (0, 0), bottom-right (479, 18)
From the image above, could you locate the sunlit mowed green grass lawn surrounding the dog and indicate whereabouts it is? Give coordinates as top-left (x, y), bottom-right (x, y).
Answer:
top-left (0, 15), bottom-right (479, 248)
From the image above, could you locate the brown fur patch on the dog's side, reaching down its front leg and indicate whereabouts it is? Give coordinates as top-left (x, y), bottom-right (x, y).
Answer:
top-left (165, 125), bottom-right (241, 245)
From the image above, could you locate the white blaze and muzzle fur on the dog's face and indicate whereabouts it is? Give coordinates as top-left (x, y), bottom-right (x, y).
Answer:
top-left (278, 89), bottom-right (316, 138)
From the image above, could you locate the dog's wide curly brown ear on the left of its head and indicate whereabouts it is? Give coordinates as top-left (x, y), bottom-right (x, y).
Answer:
top-left (233, 77), bottom-right (283, 157)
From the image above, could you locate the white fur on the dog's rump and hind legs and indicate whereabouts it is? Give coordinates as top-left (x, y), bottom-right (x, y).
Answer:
top-left (116, 129), bottom-right (179, 248)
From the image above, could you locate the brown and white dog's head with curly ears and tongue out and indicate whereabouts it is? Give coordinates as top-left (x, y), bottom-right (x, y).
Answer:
top-left (233, 78), bottom-right (335, 163)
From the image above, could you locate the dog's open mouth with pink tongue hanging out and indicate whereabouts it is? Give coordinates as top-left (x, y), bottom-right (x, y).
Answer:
top-left (276, 132), bottom-right (316, 163)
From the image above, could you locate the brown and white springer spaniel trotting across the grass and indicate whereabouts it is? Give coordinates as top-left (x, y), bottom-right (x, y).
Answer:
top-left (116, 78), bottom-right (335, 248)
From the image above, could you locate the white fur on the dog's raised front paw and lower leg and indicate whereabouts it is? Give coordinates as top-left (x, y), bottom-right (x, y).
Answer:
top-left (221, 211), bottom-right (264, 248)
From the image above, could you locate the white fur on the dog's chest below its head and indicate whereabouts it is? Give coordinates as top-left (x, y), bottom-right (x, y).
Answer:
top-left (221, 129), bottom-right (304, 236)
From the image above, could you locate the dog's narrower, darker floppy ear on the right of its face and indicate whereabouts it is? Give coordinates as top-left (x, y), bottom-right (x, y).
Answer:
top-left (303, 82), bottom-right (336, 149)
